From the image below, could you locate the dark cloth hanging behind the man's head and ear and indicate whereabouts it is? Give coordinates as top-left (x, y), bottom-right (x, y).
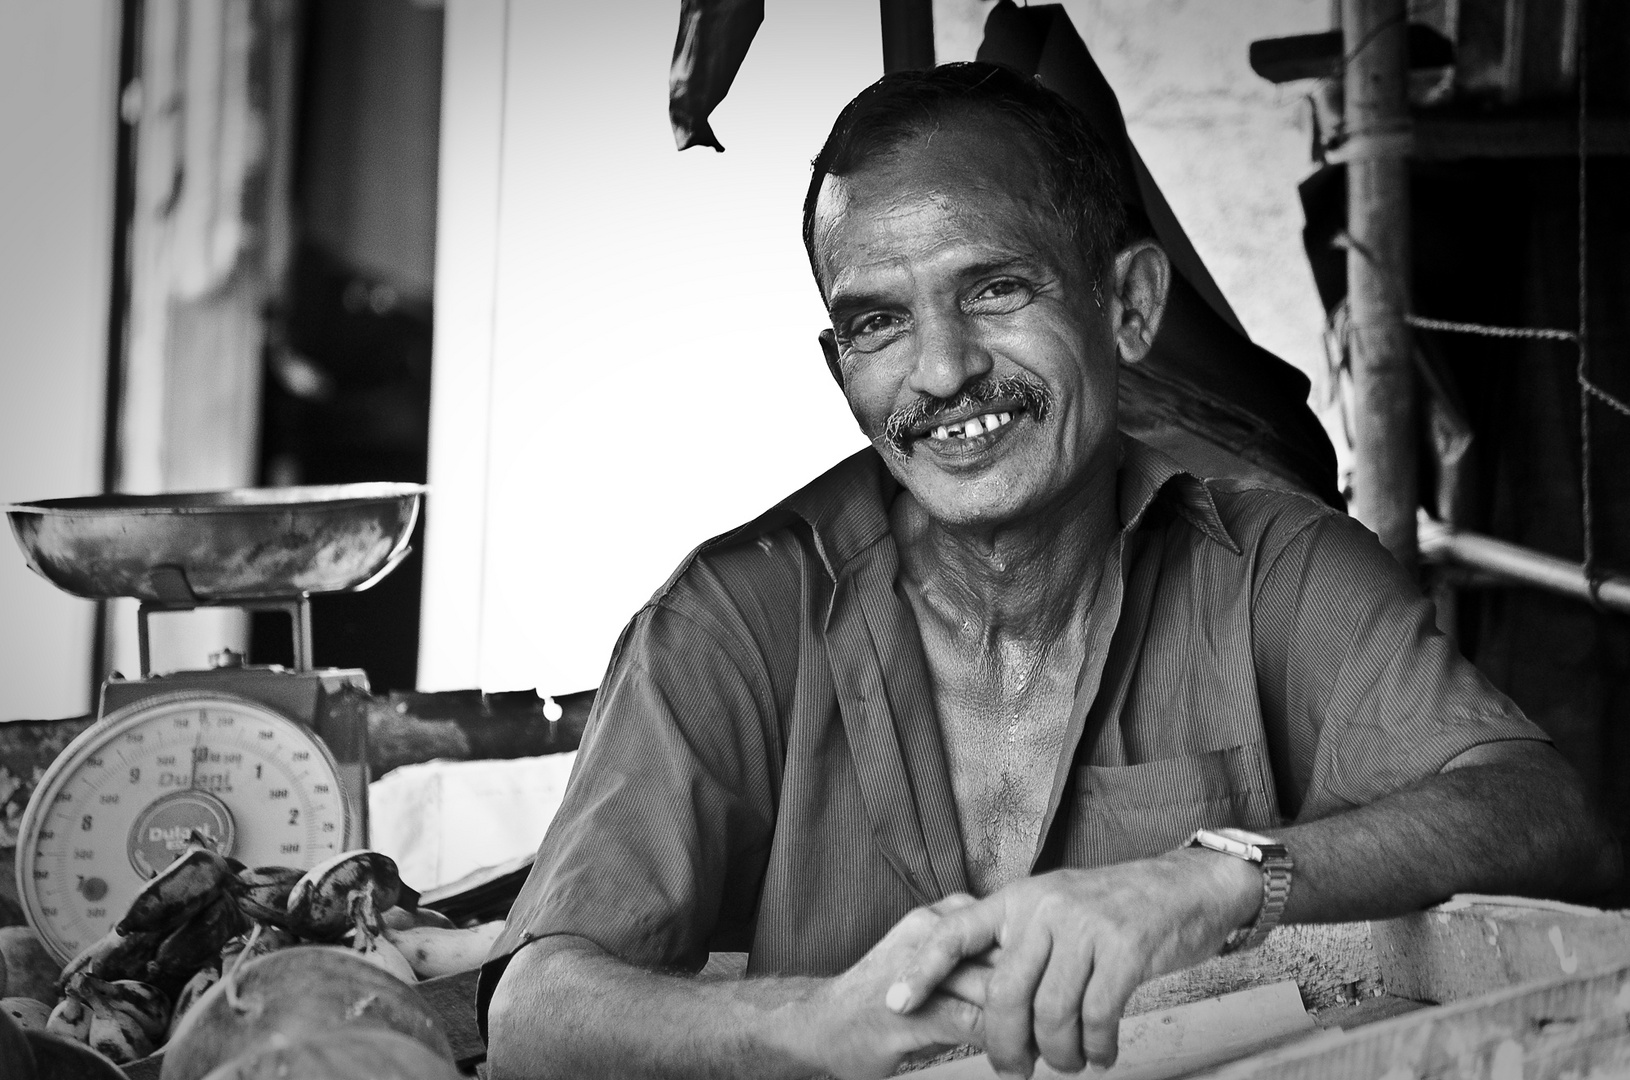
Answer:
top-left (978, 0), bottom-right (1343, 507)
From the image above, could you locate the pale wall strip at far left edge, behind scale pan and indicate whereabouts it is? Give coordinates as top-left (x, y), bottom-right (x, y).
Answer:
top-left (0, 0), bottom-right (119, 720)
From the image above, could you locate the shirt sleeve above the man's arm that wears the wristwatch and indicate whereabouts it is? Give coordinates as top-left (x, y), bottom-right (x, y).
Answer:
top-left (1252, 511), bottom-right (1545, 821)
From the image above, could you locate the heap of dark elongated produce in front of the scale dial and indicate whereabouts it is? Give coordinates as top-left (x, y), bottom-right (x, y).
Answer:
top-left (46, 844), bottom-right (502, 1064)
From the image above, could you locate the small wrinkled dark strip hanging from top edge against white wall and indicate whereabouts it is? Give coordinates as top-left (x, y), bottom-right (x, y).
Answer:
top-left (668, 0), bottom-right (764, 151)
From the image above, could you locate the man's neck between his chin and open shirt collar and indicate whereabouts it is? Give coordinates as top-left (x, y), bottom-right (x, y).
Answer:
top-left (892, 456), bottom-right (1120, 650)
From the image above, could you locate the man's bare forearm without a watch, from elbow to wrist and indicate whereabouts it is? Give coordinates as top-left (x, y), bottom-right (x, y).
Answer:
top-left (487, 937), bottom-right (815, 1080)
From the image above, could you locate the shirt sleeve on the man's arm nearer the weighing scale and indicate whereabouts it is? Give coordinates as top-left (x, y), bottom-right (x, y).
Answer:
top-left (478, 604), bottom-right (781, 1028)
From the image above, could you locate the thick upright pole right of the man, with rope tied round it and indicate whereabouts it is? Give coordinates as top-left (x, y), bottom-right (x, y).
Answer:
top-left (1341, 0), bottom-right (1418, 570)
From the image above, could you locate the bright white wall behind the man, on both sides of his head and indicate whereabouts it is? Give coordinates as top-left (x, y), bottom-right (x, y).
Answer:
top-left (421, 0), bottom-right (1330, 692)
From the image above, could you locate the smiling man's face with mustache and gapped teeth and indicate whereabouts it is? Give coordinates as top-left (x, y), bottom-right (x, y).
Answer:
top-left (815, 114), bottom-right (1117, 528)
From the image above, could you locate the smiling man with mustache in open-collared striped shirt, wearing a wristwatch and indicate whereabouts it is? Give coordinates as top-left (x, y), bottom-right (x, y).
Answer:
top-left (484, 65), bottom-right (1619, 1077)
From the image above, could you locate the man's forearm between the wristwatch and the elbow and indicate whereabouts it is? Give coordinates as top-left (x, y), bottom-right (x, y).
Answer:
top-left (1278, 746), bottom-right (1620, 922)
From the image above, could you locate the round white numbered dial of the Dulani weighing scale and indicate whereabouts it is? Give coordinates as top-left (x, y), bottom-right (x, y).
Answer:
top-left (16, 691), bottom-right (350, 961)
